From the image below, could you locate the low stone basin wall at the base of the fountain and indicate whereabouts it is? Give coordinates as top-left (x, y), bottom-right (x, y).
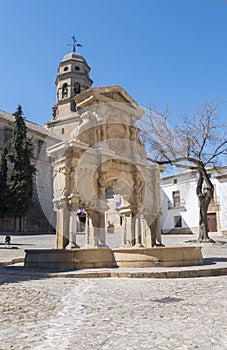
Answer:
top-left (24, 247), bottom-right (203, 270)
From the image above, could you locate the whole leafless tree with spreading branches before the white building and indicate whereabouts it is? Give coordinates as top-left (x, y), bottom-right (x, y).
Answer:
top-left (139, 103), bottom-right (227, 242)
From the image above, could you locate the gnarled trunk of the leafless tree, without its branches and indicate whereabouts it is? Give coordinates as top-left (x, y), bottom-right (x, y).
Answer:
top-left (196, 168), bottom-right (214, 243)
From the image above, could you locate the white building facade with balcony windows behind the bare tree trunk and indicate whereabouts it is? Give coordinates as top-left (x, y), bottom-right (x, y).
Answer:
top-left (161, 167), bottom-right (227, 236)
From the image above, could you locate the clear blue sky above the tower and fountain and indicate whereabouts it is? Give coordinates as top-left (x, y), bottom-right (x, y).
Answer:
top-left (0, 0), bottom-right (227, 125)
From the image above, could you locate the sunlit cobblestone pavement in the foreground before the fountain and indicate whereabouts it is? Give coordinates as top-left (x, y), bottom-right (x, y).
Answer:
top-left (0, 276), bottom-right (227, 350)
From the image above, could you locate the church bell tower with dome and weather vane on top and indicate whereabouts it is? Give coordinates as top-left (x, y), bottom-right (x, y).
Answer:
top-left (52, 36), bottom-right (93, 120)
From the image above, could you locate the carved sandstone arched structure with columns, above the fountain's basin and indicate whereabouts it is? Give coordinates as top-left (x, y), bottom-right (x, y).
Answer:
top-left (48, 87), bottom-right (161, 248)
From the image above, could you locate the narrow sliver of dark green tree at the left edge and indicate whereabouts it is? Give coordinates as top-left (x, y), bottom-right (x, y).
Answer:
top-left (0, 146), bottom-right (9, 218)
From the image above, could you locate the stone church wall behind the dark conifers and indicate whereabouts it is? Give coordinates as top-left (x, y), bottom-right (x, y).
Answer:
top-left (0, 110), bottom-right (58, 232)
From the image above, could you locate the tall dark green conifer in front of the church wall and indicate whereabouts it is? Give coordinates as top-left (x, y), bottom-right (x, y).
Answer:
top-left (9, 105), bottom-right (36, 230)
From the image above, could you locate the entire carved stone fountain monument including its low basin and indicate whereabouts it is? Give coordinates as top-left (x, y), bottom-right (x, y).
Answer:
top-left (25, 86), bottom-right (202, 269)
